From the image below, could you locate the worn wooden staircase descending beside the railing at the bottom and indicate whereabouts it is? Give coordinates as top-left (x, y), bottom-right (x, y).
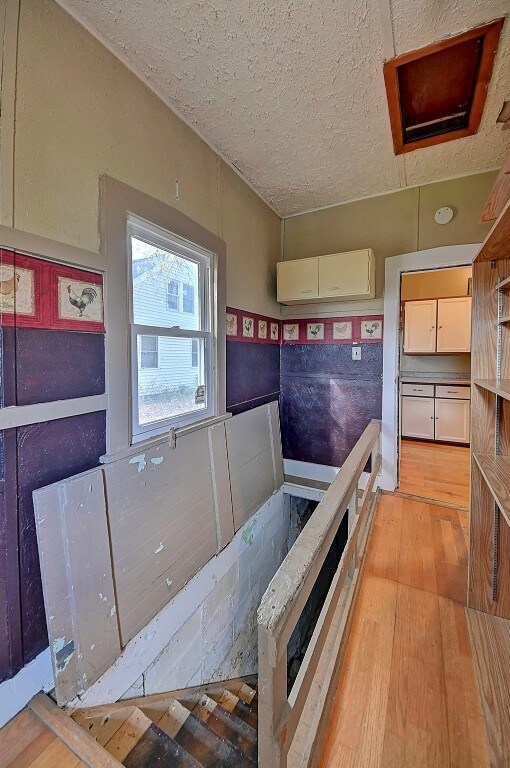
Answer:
top-left (72, 677), bottom-right (257, 768)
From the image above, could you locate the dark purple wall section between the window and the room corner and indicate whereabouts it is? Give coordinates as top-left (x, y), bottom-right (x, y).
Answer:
top-left (227, 340), bottom-right (280, 414)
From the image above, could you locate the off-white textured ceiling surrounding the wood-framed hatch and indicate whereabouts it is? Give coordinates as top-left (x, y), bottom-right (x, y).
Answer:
top-left (59, 0), bottom-right (510, 216)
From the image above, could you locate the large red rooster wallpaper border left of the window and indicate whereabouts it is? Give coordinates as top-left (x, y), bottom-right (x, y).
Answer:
top-left (0, 247), bottom-right (105, 333)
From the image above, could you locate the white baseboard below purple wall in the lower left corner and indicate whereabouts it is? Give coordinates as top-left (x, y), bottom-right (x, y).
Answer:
top-left (0, 648), bottom-right (54, 728)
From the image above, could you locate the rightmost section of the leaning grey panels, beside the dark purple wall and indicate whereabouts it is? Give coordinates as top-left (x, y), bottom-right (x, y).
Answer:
top-left (226, 403), bottom-right (283, 531)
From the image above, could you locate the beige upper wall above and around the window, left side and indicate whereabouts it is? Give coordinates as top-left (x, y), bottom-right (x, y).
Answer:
top-left (1, 0), bottom-right (281, 315)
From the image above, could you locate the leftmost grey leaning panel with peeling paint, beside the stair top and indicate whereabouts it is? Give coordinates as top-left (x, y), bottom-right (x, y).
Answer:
top-left (34, 469), bottom-right (121, 704)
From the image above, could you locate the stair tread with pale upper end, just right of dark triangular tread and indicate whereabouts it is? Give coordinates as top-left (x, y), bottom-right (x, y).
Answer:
top-left (158, 700), bottom-right (253, 768)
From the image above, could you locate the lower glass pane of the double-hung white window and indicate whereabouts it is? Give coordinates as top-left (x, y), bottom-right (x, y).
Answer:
top-left (138, 336), bottom-right (208, 425)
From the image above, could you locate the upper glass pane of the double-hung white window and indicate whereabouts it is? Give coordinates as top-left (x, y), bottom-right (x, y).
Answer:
top-left (131, 237), bottom-right (200, 330)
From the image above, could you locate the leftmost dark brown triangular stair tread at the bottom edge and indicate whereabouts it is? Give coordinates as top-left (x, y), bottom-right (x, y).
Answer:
top-left (123, 722), bottom-right (204, 768)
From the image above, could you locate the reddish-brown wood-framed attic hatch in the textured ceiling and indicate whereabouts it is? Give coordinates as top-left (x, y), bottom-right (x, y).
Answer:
top-left (384, 19), bottom-right (504, 155)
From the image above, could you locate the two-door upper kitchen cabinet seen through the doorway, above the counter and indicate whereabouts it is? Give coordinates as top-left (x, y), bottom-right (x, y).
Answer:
top-left (404, 296), bottom-right (471, 355)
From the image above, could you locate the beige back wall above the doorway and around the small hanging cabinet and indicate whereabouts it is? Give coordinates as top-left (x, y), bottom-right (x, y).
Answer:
top-left (283, 171), bottom-right (497, 315)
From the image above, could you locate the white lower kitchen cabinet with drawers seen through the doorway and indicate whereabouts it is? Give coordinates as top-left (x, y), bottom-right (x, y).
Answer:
top-left (401, 383), bottom-right (471, 443)
